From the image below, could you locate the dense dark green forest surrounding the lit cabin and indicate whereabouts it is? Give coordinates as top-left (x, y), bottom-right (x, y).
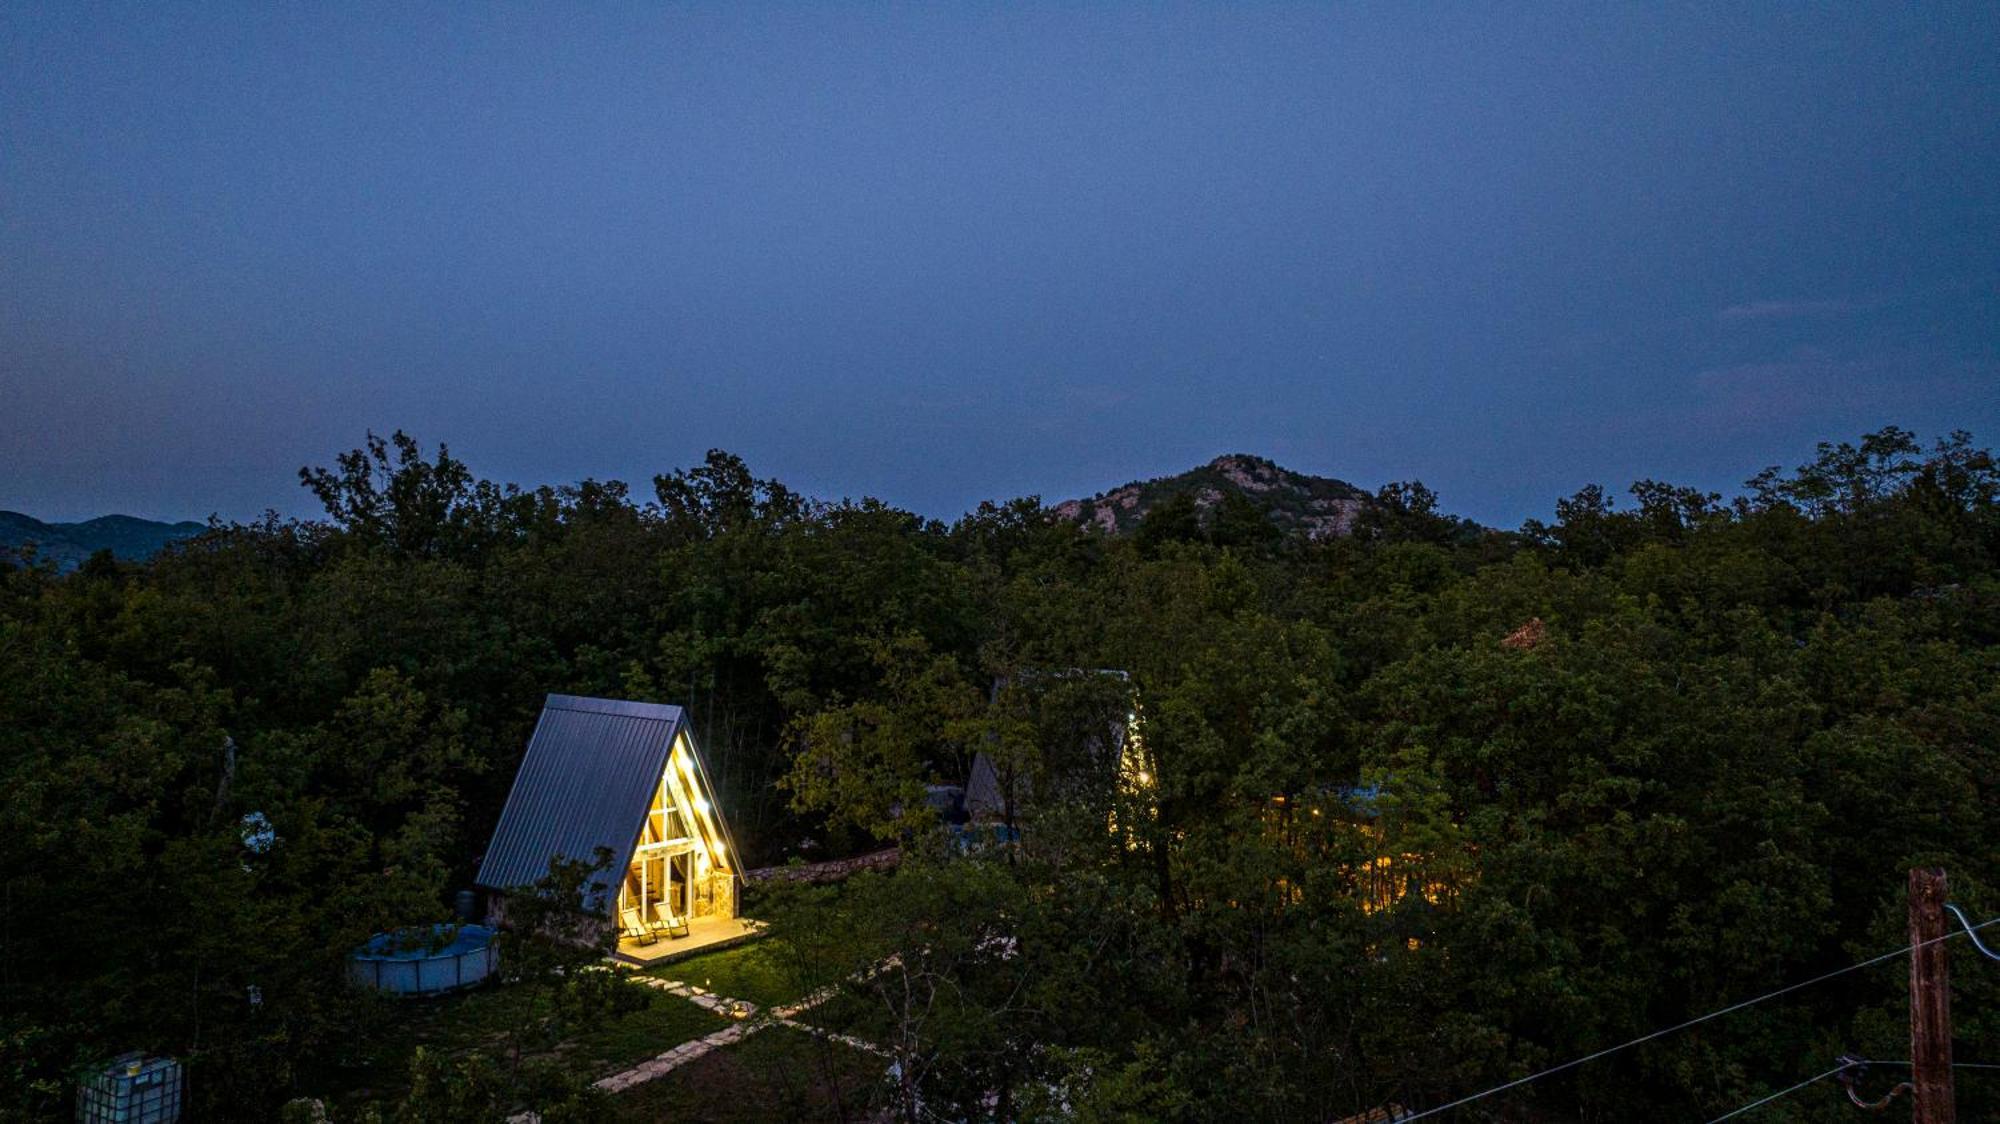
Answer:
top-left (0, 428), bottom-right (2000, 1120)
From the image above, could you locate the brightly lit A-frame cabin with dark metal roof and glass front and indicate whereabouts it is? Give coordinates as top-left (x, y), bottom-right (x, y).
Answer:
top-left (478, 694), bottom-right (748, 960)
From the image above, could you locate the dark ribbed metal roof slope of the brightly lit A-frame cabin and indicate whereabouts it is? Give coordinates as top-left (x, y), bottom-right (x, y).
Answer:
top-left (478, 694), bottom-right (692, 908)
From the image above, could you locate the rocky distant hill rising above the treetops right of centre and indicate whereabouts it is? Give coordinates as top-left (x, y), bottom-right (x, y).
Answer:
top-left (1054, 452), bottom-right (1372, 538)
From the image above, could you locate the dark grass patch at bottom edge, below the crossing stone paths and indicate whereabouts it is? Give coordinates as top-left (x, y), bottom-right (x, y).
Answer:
top-left (612, 1026), bottom-right (884, 1124)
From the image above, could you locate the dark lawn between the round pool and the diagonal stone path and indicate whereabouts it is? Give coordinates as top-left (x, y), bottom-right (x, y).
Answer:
top-left (324, 982), bottom-right (728, 1104)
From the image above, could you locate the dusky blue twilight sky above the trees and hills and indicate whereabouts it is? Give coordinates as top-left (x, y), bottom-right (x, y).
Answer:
top-left (0, 2), bottom-right (2000, 526)
